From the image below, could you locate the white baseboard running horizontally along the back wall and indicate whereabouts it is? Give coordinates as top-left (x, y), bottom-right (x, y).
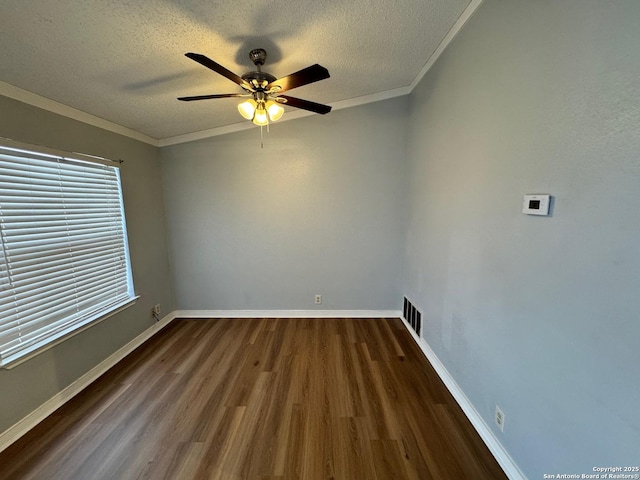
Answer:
top-left (174, 310), bottom-right (402, 318)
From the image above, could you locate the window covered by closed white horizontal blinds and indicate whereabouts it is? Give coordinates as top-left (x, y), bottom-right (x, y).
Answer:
top-left (0, 142), bottom-right (134, 366)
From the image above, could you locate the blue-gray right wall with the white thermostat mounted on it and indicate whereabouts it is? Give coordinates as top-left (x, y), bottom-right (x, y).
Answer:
top-left (403, 0), bottom-right (640, 479)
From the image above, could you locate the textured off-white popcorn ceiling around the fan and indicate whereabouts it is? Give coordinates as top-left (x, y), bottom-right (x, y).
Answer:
top-left (0, 0), bottom-right (470, 139)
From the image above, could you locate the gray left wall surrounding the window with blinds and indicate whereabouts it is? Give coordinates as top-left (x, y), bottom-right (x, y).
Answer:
top-left (0, 96), bottom-right (174, 432)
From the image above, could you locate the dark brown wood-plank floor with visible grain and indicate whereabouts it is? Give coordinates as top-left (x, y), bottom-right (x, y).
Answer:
top-left (0, 319), bottom-right (506, 480)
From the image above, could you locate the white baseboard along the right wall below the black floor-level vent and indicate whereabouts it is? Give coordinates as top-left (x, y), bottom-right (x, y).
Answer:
top-left (400, 315), bottom-right (527, 480)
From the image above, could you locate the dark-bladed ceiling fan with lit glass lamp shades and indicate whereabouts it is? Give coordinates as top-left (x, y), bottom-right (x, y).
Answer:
top-left (178, 48), bottom-right (331, 126)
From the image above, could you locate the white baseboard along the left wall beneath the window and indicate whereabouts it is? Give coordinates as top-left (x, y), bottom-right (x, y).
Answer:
top-left (0, 312), bottom-right (175, 452)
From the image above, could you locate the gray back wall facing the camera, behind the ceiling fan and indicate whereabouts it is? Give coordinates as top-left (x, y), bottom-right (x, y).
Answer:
top-left (161, 97), bottom-right (407, 309)
